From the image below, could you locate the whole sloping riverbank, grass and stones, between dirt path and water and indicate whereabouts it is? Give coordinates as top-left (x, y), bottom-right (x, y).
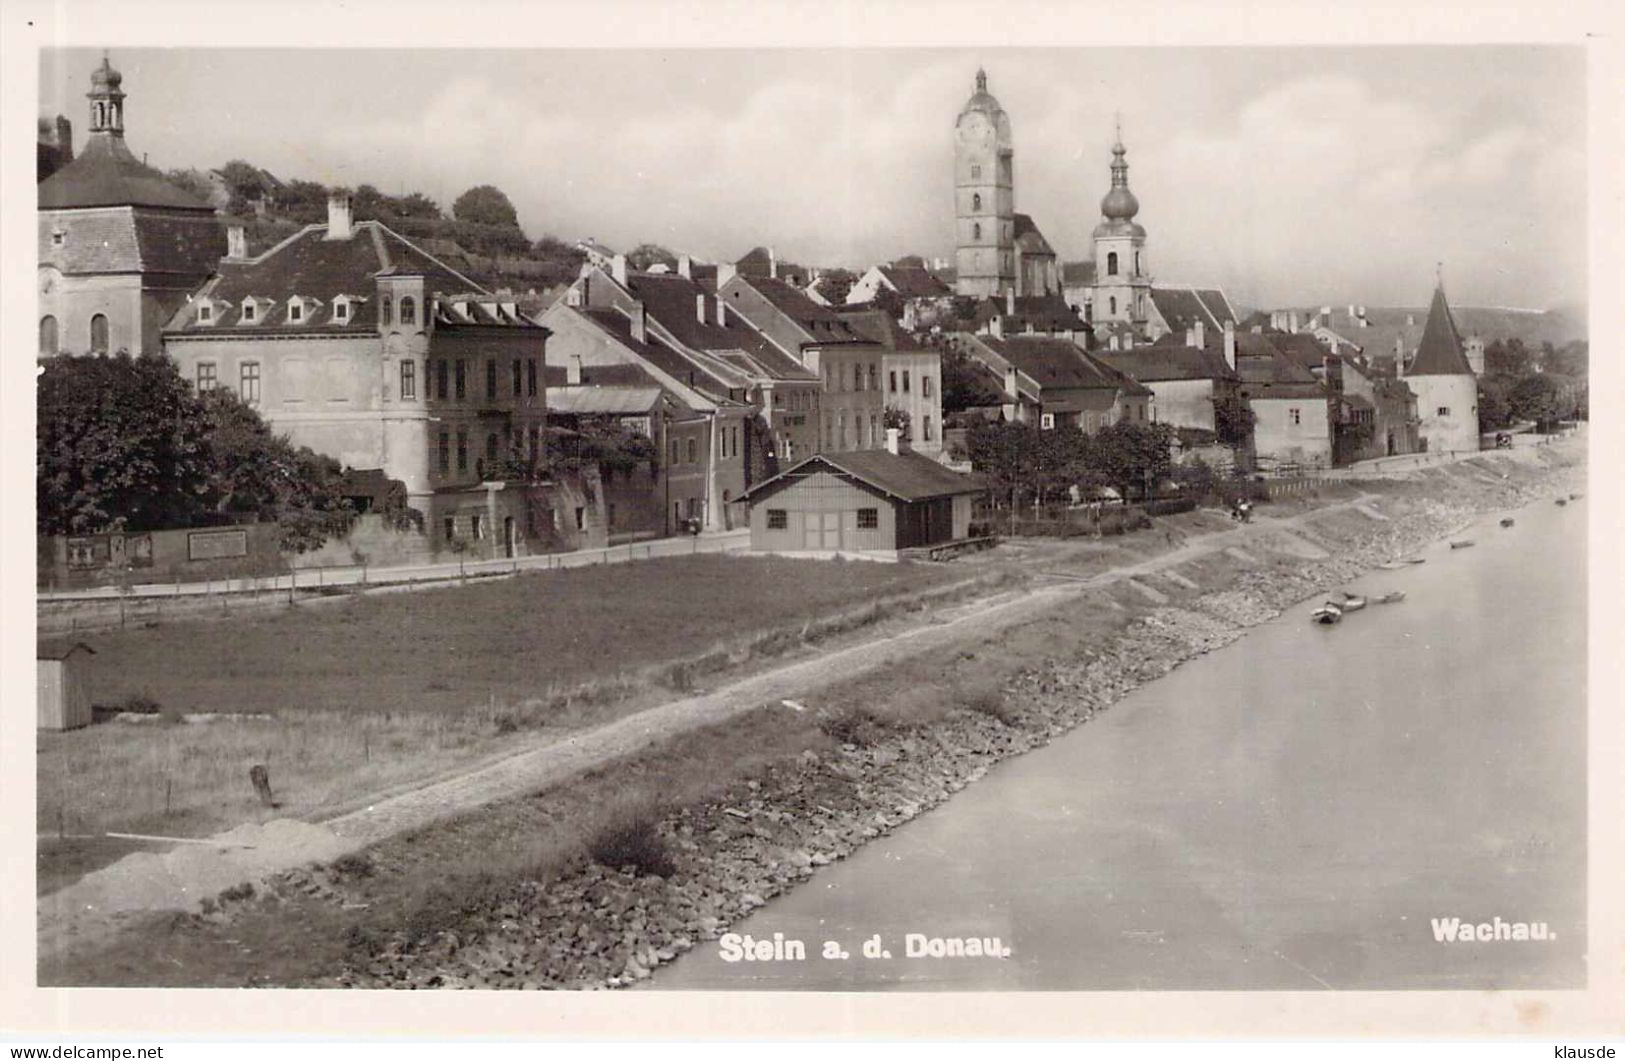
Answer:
top-left (42, 435), bottom-right (1583, 988)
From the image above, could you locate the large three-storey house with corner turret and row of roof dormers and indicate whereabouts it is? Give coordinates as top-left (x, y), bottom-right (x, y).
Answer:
top-left (163, 195), bottom-right (554, 556)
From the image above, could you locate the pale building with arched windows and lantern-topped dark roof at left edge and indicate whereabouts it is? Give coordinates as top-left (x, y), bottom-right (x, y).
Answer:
top-left (37, 57), bottom-right (226, 357)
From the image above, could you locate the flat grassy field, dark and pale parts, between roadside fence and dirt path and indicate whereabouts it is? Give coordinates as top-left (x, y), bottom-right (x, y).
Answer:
top-left (37, 556), bottom-right (965, 864)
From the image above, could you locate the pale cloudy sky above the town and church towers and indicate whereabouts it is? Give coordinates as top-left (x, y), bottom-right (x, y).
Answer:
top-left (39, 45), bottom-right (1588, 309)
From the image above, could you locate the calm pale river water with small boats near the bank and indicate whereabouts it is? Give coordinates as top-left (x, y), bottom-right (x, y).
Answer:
top-left (650, 500), bottom-right (1588, 991)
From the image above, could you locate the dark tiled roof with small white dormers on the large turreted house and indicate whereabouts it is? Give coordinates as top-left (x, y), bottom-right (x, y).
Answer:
top-left (169, 221), bottom-right (500, 333)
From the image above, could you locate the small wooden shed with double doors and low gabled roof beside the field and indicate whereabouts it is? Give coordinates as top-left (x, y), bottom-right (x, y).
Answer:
top-left (746, 450), bottom-right (983, 556)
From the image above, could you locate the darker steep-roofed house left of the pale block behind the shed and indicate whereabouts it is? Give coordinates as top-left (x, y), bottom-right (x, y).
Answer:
top-left (717, 273), bottom-right (886, 451)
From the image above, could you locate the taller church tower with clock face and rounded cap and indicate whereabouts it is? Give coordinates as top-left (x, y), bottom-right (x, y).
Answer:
top-left (954, 70), bottom-right (1016, 299)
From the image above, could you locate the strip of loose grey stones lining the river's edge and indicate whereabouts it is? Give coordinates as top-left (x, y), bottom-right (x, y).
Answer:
top-left (320, 447), bottom-right (1584, 988)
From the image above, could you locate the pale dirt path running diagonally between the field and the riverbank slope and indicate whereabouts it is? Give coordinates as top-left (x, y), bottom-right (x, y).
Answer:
top-left (39, 494), bottom-right (1375, 955)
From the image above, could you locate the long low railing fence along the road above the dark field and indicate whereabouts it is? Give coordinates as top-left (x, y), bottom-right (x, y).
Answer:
top-left (36, 531), bottom-right (751, 634)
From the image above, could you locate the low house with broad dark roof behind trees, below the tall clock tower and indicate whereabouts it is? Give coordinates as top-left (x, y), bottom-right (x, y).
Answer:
top-left (952, 333), bottom-right (1155, 434)
